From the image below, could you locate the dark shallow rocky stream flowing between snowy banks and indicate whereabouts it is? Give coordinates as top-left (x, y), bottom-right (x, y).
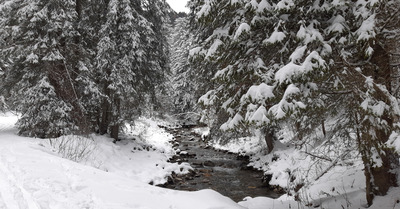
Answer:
top-left (158, 128), bottom-right (280, 202)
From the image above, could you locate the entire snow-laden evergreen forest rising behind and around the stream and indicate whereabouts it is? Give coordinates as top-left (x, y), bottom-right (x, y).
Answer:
top-left (0, 0), bottom-right (400, 208)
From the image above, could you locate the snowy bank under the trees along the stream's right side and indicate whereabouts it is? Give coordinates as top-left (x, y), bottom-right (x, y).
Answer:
top-left (195, 128), bottom-right (400, 209)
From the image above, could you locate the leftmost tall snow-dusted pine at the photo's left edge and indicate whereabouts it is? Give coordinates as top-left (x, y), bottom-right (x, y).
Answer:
top-left (2, 0), bottom-right (86, 137)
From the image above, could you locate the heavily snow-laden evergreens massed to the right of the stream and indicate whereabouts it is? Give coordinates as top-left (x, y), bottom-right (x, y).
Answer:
top-left (189, 0), bottom-right (400, 205)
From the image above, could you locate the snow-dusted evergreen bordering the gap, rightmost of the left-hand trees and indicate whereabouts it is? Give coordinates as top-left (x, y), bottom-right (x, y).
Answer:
top-left (96, 0), bottom-right (171, 139)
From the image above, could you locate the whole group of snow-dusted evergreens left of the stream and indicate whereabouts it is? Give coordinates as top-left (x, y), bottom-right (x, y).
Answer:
top-left (0, 0), bottom-right (173, 139)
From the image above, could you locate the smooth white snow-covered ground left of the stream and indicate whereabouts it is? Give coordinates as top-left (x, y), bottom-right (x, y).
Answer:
top-left (0, 114), bottom-right (243, 209)
